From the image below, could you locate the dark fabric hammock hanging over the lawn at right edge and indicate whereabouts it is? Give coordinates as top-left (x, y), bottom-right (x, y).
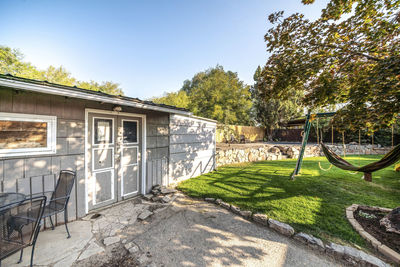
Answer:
top-left (321, 143), bottom-right (400, 173)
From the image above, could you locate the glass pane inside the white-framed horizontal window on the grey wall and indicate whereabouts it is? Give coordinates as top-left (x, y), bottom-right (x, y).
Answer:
top-left (0, 120), bottom-right (47, 149)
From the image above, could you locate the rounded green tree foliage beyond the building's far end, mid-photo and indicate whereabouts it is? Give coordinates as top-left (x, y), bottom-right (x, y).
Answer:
top-left (153, 66), bottom-right (252, 125)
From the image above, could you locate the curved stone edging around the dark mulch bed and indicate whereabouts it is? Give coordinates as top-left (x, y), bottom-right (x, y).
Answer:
top-left (346, 204), bottom-right (400, 264)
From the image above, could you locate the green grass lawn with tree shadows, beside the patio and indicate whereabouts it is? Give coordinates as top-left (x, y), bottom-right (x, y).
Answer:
top-left (178, 156), bottom-right (400, 247)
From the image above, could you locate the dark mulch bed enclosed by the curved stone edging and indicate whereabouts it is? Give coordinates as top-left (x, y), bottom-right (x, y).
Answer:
top-left (354, 207), bottom-right (400, 253)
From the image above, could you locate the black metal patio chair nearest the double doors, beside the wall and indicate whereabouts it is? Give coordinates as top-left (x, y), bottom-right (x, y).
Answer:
top-left (43, 170), bottom-right (76, 238)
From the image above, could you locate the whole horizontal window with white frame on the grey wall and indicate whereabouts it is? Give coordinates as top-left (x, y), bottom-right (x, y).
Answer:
top-left (0, 112), bottom-right (57, 157)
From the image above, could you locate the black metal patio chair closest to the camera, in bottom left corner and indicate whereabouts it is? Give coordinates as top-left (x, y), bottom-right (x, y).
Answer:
top-left (0, 196), bottom-right (46, 266)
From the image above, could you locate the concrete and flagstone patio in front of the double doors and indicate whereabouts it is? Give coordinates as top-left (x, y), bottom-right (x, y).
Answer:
top-left (2, 193), bottom-right (341, 266)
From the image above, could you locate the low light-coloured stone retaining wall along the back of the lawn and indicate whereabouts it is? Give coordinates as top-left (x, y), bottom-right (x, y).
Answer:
top-left (216, 143), bottom-right (390, 167)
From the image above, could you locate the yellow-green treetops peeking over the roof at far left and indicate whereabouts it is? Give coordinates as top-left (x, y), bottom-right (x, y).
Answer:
top-left (0, 46), bottom-right (123, 95)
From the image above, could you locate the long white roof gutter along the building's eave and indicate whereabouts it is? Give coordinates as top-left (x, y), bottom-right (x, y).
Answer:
top-left (0, 78), bottom-right (192, 116)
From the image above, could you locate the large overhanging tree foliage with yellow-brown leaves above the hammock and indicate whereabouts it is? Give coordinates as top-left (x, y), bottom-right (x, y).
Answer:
top-left (262, 0), bottom-right (400, 131)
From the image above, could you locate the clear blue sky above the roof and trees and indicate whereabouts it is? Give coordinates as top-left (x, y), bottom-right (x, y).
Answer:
top-left (0, 0), bottom-right (327, 99)
